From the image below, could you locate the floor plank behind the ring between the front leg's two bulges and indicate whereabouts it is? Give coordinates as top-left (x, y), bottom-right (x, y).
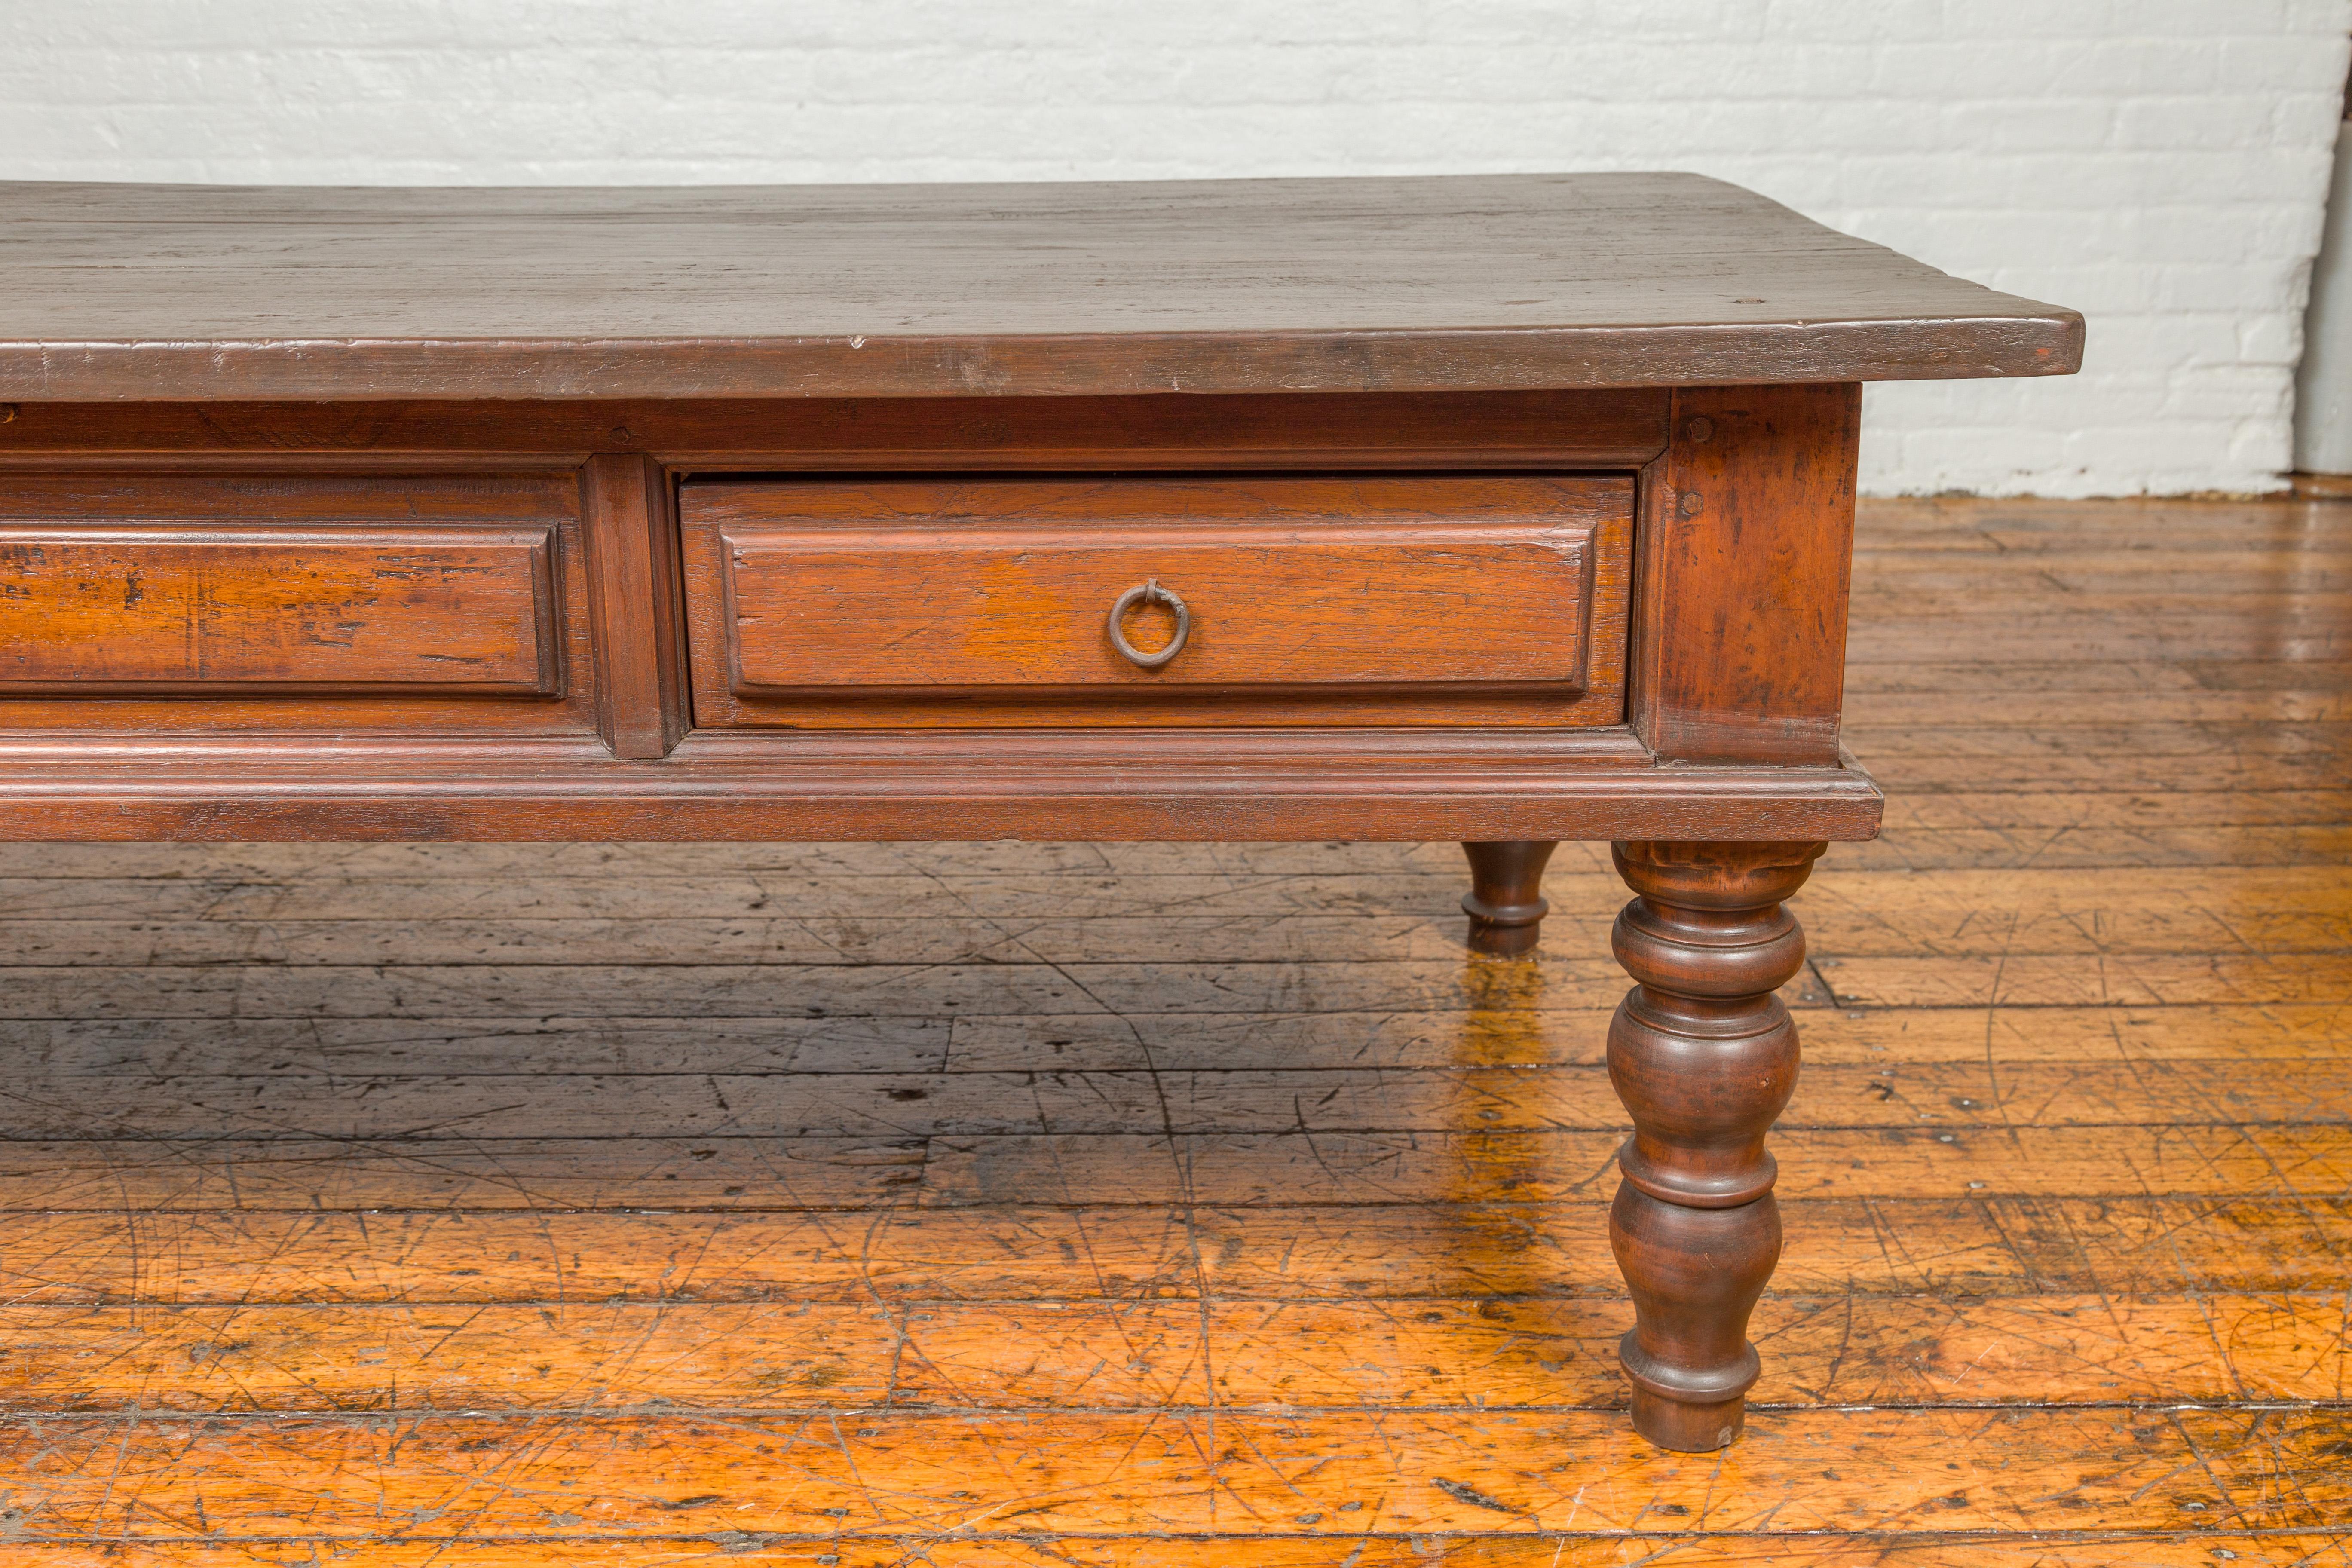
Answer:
top-left (0, 1124), bottom-right (2352, 1213)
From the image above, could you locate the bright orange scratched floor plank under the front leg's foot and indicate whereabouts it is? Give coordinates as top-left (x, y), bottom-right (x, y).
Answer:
top-left (0, 1406), bottom-right (2352, 1540)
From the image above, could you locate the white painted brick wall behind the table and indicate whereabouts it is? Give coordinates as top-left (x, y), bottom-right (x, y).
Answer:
top-left (0, 0), bottom-right (2352, 496)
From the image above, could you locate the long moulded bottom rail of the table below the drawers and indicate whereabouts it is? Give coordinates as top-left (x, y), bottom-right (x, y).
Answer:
top-left (0, 726), bottom-right (1884, 839)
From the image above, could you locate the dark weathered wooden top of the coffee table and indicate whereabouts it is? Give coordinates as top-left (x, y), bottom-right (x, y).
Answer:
top-left (0, 174), bottom-right (2082, 402)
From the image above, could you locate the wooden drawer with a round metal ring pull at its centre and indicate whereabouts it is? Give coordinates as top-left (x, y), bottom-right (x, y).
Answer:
top-left (680, 475), bottom-right (1635, 726)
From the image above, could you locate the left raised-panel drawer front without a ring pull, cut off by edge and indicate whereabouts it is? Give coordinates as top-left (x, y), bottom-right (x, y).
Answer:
top-left (0, 475), bottom-right (586, 729)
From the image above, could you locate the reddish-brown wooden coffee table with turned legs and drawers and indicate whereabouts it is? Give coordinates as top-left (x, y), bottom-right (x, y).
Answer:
top-left (0, 174), bottom-right (2082, 1451)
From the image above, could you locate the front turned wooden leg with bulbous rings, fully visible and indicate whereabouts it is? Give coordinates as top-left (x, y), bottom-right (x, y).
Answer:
top-left (1609, 842), bottom-right (1825, 1453)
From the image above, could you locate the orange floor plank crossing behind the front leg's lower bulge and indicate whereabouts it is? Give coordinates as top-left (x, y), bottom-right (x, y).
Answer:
top-left (0, 1204), bottom-right (2352, 1305)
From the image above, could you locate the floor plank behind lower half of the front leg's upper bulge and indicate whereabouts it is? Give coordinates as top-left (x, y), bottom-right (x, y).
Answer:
top-left (0, 1060), bottom-right (2352, 1140)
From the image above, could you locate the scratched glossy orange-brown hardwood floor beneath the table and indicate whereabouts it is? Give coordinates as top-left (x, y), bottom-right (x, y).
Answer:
top-left (0, 501), bottom-right (2352, 1568)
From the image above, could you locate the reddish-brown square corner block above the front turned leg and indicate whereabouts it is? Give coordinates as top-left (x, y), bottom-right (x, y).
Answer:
top-left (1632, 386), bottom-right (1863, 764)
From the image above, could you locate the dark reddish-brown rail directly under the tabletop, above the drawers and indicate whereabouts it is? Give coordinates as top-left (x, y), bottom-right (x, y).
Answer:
top-left (0, 388), bottom-right (1668, 472)
